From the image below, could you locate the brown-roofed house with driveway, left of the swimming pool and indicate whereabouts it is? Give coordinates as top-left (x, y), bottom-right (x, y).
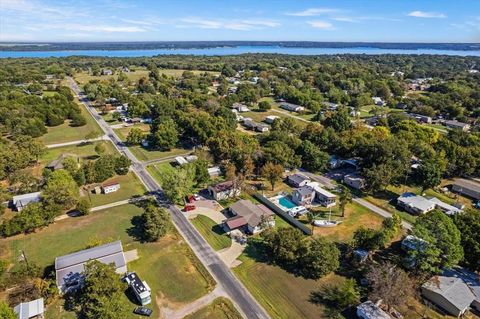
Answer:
top-left (223, 199), bottom-right (275, 234)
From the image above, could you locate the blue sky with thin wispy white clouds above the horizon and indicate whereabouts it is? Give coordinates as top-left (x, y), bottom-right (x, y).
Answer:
top-left (0, 0), bottom-right (480, 42)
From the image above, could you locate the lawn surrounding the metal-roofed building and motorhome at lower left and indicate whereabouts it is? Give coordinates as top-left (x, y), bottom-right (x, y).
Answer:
top-left (0, 205), bottom-right (214, 319)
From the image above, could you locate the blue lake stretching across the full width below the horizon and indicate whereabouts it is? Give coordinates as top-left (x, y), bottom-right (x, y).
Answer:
top-left (0, 46), bottom-right (480, 58)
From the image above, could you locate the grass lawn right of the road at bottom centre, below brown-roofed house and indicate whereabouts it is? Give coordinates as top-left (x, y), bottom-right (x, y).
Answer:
top-left (233, 248), bottom-right (343, 319)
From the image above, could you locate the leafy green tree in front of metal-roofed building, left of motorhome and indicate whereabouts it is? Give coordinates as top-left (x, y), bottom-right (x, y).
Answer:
top-left (80, 260), bottom-right (128, 319)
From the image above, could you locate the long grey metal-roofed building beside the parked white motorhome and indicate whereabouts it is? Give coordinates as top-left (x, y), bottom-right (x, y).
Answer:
top-left (55, 240), bottom-right (127, 293)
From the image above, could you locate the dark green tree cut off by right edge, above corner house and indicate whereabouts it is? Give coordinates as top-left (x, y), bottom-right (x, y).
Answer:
top-left (453, 209), bottom-right (480, 271)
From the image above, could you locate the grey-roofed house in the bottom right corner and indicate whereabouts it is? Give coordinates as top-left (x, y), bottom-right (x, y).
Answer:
top-left (421, 268), bottom-right (480, 317)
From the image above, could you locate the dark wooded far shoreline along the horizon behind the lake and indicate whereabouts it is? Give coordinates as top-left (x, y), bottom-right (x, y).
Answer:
top-left (0, 41), bottom-right (480, 52)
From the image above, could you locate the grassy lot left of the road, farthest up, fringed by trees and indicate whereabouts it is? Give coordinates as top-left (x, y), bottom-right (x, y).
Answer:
top-left (39, 104), bottom-right (102, 145)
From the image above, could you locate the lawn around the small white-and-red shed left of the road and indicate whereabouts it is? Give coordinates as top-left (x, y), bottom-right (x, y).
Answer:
top-left (86, 172), bottom-right (146, 207)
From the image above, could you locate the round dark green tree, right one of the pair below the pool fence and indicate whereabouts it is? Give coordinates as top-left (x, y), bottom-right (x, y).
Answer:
top-left (297, 237), bottom-right (340, 279)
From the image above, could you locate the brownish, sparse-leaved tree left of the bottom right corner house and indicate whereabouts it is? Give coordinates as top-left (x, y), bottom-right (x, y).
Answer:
top-left (366, 261), bottom-right (414, 308)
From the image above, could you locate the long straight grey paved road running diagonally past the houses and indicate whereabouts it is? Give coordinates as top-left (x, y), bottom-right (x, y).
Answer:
top-left (68, 77), bottom-right (270, 319)
